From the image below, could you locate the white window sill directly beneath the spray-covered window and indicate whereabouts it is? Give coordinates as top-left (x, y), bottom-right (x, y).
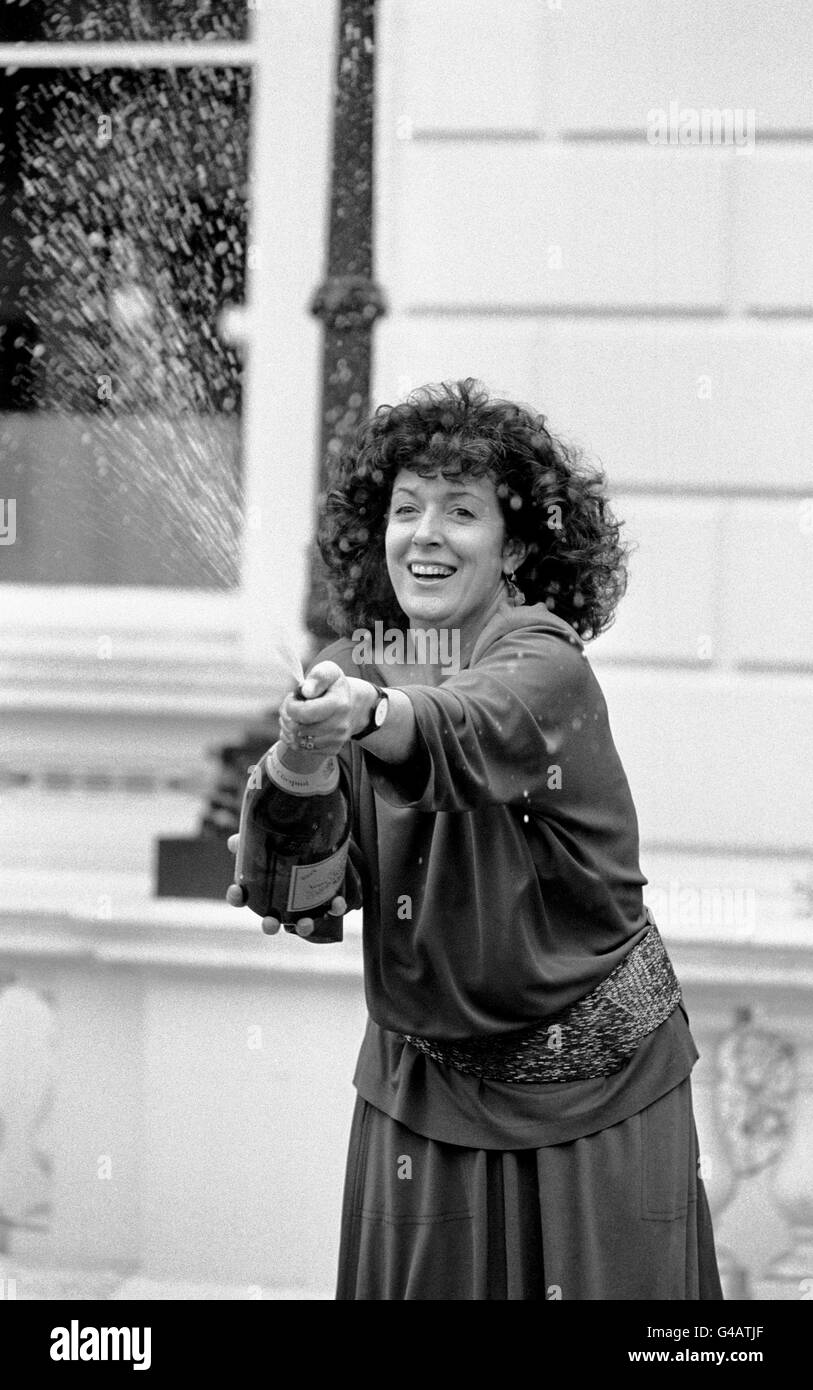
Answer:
top-left (0, 584), bottom-right (307, 719)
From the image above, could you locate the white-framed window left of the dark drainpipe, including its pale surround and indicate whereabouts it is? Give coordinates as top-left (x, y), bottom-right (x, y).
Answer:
top-left (0, 0), bottom-right (330, 678)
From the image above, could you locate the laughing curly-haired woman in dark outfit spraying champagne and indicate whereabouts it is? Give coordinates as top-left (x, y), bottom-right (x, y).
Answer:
top-left (257, 378), bottom-right (723, 1300)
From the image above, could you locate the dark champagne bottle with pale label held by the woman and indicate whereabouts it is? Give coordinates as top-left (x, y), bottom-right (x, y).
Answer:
top-left (227, 744), bottom-right (350, 941)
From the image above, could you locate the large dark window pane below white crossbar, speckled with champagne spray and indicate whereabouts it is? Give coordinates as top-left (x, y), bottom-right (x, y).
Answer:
top-left (0, 68), bottom-right (249, 588)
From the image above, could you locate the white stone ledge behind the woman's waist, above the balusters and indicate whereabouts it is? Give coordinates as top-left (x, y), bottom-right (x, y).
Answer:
top-left (0, 870), bottom-right (813, 994)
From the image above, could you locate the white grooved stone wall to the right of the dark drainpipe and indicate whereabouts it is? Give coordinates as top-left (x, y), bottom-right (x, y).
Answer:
top-left (374, 0), bottom-right (813, 872)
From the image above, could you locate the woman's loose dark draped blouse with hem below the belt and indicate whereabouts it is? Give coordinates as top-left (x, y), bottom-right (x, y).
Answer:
top-left (318, 605), bottom-right (698, 1148)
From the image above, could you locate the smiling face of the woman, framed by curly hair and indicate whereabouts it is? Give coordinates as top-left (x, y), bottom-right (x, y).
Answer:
top-left (385, 468), bottom-right (523, 635)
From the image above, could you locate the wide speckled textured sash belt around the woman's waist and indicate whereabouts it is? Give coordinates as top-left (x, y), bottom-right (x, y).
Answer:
top-left (402, 908), bottom-right (681, 1081)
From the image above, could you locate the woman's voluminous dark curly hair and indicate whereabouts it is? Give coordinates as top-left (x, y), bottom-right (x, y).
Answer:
top-left (318, 377), bottom-right (630, 641)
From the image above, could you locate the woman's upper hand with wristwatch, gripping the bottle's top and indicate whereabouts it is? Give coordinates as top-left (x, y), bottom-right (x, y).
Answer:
top-left (279, 662), bottom-right (375, 758)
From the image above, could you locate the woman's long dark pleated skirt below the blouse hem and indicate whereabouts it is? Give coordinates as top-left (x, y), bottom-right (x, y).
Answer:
top-left (336, 1077), bottom-right (723, 1300)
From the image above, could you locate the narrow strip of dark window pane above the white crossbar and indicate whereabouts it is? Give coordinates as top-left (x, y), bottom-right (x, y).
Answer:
top-left (0, 0), bottom-right (249, 43)
